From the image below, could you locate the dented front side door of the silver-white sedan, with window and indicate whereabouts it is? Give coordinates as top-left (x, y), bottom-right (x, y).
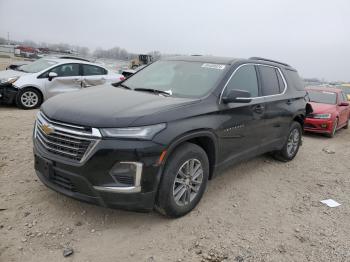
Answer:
top-left (45, 63), bottom-right (82, 98)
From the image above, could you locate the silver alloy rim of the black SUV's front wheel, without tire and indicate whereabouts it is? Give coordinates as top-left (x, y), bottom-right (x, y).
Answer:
top-left (173, 159), bottom-right (203, 206)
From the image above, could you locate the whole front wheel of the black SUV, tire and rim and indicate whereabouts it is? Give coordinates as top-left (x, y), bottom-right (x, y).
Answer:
top-left (156, 143), bottom-right (209, 218)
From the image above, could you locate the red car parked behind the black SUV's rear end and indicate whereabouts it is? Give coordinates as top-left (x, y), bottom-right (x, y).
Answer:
top-left (304, 87), bottom-right (350, 137)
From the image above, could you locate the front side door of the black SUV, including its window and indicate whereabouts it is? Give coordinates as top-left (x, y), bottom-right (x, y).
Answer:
top-left (217, 64), bottom-right (265, 162)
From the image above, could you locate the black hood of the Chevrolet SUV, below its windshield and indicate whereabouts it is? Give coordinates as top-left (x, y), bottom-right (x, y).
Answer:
top-left (41, 85), bottom-right (200, 127)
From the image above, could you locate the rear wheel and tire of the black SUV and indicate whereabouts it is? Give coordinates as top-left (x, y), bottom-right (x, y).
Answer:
top-left (274, 121), bottom-right (302, 162)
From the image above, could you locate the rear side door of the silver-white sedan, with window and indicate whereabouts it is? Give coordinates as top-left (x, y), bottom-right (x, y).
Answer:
top-left (82, 64), bottom-right (107, 87)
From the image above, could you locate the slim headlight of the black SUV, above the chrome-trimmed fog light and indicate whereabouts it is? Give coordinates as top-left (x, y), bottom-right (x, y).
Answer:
top-left (101, 123), bottom-right (166, 140)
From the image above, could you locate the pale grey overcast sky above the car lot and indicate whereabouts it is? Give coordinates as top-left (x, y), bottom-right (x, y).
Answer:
top-left (0, 0), bottom-right (350, 81)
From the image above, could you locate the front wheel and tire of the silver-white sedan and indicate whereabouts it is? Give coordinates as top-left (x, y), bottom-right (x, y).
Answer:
top-left (16, 87), bottom-right (43, 109)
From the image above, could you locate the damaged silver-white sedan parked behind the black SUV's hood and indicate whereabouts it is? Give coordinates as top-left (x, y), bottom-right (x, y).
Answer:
top-left (0, 57), bottom-right (124, 109)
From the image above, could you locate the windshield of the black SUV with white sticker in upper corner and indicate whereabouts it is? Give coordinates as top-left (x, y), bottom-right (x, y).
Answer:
top-left (123, 61), bottom-right (227, 98)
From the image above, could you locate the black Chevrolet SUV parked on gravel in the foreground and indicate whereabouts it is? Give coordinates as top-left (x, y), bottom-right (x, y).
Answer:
top-left (34, 56), bottom-right (306, 217)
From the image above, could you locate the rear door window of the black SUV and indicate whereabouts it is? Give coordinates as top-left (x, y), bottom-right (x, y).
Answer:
top-left (259, 66), bottom-right (280, 96)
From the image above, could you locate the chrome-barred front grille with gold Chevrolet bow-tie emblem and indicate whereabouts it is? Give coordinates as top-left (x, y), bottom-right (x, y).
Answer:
top-left (34, 112), bottom-right (101, 162)
